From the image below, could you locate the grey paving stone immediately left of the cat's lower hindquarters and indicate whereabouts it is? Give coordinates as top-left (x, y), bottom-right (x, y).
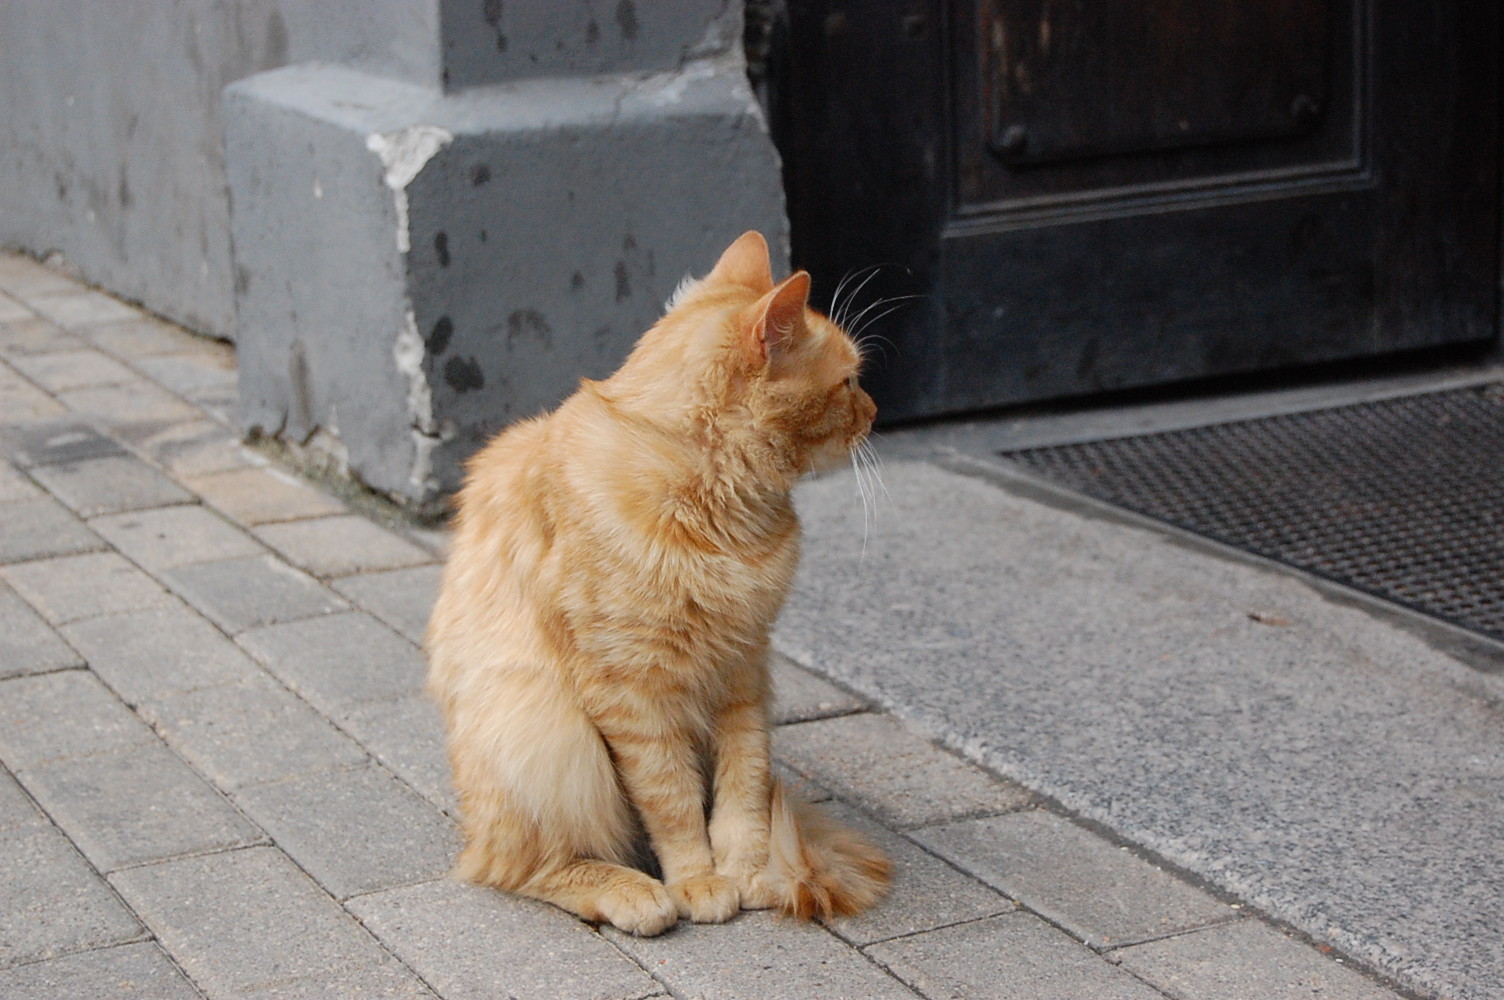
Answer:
top-left (235, 765), bottom-right (459, 899)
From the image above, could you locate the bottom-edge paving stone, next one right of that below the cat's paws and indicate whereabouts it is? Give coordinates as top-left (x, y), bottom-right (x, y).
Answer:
top-left (866, 913), bottom-right (1161, 1000)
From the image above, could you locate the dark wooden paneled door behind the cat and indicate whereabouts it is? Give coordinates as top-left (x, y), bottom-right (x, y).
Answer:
top-left (772, 0), bottom-right (1501, 420)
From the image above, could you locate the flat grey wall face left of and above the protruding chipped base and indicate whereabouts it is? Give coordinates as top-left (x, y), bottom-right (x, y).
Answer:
top-left (0, 0), bottom-right (441, 337)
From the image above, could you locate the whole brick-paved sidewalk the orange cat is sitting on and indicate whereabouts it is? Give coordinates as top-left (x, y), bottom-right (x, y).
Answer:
top-left (0, 256), bottom-right (1399, 1000)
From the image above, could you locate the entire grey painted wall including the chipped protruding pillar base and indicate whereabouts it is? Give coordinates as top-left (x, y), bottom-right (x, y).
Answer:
top-left (0, 0), bottom-right (788, 505)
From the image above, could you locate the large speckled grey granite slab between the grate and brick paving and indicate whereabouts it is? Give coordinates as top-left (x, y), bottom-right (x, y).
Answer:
top-left (776, 463), bottom-right (1504, 1000)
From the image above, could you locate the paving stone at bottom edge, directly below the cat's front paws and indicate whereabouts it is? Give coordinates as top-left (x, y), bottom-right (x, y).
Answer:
top-left (602, 910), bottom-right (914, 1000)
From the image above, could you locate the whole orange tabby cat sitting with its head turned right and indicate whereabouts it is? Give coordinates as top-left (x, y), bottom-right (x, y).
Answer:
top-left (429, 233), bottom-right (889, 934)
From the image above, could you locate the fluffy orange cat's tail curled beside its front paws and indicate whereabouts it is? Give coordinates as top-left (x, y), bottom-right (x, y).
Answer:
top-left (769, 777), bottom-right (893, 920)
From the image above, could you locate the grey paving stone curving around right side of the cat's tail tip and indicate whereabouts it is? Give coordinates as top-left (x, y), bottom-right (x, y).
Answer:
top-left (821, 805), bottom-right (1015, 946)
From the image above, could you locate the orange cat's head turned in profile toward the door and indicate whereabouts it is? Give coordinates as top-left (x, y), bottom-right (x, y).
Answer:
top-left (612, 232), bottom-right (877, 477)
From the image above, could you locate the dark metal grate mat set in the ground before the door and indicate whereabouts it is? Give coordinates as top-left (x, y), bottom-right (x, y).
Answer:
top-left (1003, 383), bottom-right (1504, 639)
